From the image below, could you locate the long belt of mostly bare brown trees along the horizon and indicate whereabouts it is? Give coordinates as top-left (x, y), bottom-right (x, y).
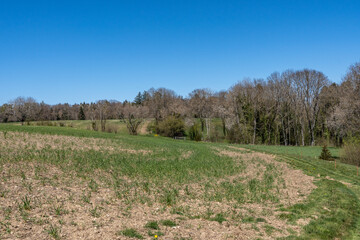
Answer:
top-left (0, 62), bottom-right (360, 146)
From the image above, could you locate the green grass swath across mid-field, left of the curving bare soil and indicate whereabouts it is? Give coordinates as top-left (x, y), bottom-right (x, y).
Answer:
top-left (0, 124), bottom-right (241, 188)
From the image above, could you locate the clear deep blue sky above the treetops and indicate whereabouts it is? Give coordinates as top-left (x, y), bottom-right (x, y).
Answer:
top-left (0, 0), bottom-right (360, 104)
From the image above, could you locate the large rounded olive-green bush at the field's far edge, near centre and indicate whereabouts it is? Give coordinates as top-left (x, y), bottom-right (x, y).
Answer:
top-left (157, 116), bottom-right (185, 137)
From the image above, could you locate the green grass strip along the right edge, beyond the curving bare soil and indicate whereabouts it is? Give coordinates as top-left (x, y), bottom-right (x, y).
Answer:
top-left (243, 145), bottom-right (360, 239)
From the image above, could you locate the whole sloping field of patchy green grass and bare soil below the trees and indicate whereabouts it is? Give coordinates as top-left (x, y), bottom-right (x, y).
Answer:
top-left (0, 122), bottom-right (360, 239)
